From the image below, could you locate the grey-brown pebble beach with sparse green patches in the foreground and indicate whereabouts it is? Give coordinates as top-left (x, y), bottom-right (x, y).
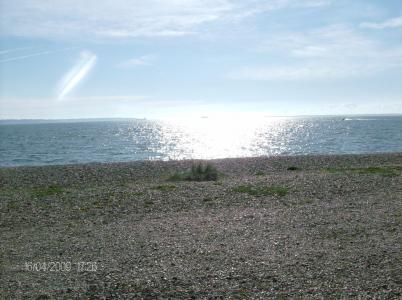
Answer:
top-left (0, 153), bottom-right (402, 299)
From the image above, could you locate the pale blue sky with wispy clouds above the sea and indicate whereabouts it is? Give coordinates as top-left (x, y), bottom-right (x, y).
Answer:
top-left (0, 0), bottom-right (402, 119)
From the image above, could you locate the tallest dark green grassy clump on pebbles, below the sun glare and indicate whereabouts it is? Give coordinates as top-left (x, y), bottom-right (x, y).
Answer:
top-left (169, 163), bottom-right (220, 181)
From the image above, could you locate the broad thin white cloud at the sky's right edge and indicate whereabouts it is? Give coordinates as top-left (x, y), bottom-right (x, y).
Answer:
top-left (227, 26), bottom-right (402, 80)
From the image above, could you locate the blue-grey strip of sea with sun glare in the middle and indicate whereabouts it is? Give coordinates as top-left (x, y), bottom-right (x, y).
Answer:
top-left (0, 116), bottom-right (402, 166)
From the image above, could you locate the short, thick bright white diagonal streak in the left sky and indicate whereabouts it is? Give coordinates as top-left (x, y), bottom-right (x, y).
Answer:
top-left (57, 51), bottom-right (97, 100)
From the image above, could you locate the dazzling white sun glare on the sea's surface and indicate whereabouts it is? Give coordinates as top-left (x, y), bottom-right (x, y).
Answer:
top-left (155, 115), bottom-right (280, 159)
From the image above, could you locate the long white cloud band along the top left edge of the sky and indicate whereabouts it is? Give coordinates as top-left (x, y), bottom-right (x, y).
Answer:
top-left (0, 0), bottom-right (329, 39)
